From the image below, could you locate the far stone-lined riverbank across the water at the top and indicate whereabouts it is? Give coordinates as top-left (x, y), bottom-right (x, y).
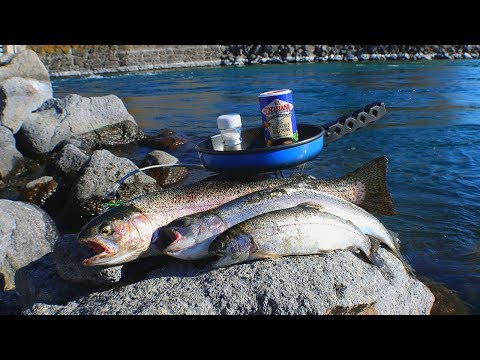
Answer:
top-left (24, 45), bottom-right (480, 77)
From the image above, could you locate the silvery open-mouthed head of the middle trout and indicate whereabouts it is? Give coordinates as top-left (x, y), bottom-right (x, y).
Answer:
top-left (162, 213), bottom-right (227, 260)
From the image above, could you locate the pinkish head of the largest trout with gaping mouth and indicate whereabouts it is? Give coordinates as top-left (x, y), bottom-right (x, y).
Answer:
top-left (78, 206), bottom-right (155, 266)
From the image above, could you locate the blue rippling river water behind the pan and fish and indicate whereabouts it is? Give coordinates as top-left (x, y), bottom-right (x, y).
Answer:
top-left (53, 60), bottom-right (480, 314)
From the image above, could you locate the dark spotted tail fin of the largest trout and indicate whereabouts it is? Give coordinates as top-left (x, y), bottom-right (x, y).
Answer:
top-left (340, 156), bottom-right (397, 216)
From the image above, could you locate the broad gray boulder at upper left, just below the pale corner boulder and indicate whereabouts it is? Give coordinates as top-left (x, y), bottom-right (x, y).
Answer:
top-left (17, 94), bottom-right (138, 154)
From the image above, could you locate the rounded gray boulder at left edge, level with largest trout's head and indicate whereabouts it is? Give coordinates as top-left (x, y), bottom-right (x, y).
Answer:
top-left (0, 199), bottom-right (57, 290)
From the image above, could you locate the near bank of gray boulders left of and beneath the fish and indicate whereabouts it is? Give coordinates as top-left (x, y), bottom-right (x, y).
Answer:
top-left (0, 50), bottom-right (435, 314)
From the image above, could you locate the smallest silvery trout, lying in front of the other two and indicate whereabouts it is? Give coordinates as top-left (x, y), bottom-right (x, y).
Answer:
top-left (208, 203), bottom-right (372, 268)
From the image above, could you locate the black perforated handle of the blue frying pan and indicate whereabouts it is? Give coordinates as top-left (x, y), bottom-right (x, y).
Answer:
top-left (323, 102), bottom-right (387, 146)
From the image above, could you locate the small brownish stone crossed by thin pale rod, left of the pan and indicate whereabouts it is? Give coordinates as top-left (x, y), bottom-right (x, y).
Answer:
top-left (140, 150), bottom-right (188, 186)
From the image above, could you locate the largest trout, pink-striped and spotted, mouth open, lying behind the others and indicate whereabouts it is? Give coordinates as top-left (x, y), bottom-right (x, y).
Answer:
top-left (78, 156), bottom-right (395, 265)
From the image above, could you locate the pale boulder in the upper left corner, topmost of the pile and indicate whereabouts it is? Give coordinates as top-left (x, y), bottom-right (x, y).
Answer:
top-left (0, 50), bottom-right (53, 134)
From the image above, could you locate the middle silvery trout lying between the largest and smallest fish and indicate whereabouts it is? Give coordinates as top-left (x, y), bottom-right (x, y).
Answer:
top-left (162, 180), bottom-right (398, 260)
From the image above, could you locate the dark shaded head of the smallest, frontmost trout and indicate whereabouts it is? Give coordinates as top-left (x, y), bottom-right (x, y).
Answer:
top-left (208, 231), bottom-right (254, 268)
